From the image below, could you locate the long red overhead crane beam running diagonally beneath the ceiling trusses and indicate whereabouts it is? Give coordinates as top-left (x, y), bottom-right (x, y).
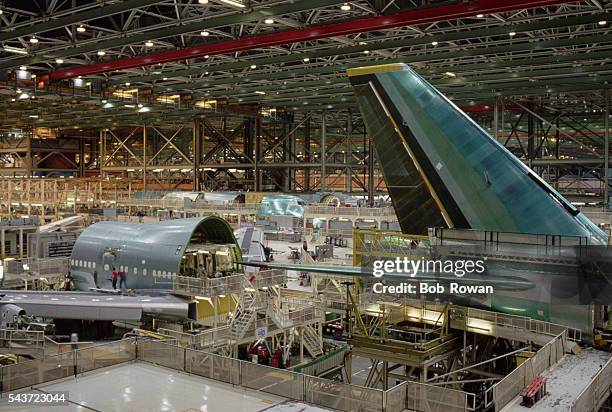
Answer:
top-left (46, 0), bottom-right (577, 80)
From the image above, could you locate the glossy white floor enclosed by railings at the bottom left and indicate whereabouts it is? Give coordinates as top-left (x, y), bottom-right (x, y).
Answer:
top-left (0, 362), bottom-right (286, 412)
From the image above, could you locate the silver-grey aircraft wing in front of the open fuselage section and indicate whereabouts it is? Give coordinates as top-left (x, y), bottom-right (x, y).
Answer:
top-left (0, 290), bottom-right (195, 321)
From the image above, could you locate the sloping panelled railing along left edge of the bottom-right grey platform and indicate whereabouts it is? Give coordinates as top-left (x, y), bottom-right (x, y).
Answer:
top-left (485, 331), bottom-right (567, 410)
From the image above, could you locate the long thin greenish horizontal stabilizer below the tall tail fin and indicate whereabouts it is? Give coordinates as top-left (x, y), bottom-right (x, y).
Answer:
top-left (241, 262), bottom-right (535, 291)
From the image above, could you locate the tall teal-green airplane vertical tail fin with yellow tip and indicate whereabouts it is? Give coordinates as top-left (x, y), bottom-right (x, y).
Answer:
top-left (348, 64), bottom-right (607, 244)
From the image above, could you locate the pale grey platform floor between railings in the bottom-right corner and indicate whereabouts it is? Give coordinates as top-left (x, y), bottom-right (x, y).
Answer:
top-left (502, 348), bottom-right (610, 412)
